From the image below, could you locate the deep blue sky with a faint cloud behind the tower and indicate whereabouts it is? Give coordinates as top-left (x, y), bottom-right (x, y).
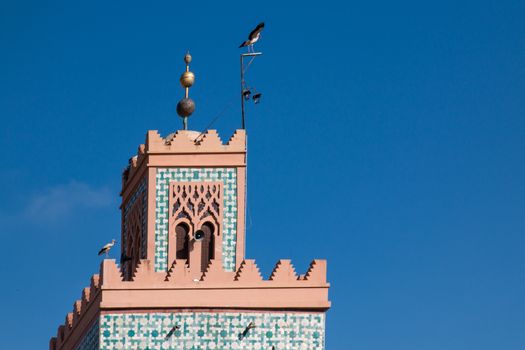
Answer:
top-left (0, 0), bottom-right (525, 350)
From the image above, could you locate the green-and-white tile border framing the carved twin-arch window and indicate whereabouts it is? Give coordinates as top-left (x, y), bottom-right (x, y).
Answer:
top-left (155, 168), bottom-right (237, 271)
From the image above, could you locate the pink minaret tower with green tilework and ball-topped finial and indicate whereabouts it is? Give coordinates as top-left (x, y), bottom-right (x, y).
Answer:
top-left (50, 54), bottom-right (330, 350)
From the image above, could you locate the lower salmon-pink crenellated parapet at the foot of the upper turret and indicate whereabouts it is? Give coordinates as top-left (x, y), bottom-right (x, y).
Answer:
top-left (49, 259), bottom-right (330, 350)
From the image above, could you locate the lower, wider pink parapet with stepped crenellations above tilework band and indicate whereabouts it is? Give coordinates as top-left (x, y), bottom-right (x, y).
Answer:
top-left (50, 259), bottom-right (330, 350)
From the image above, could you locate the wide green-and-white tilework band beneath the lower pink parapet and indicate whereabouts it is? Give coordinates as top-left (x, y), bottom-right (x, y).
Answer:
top-left (100, 312), bottom-right (325, 350)
